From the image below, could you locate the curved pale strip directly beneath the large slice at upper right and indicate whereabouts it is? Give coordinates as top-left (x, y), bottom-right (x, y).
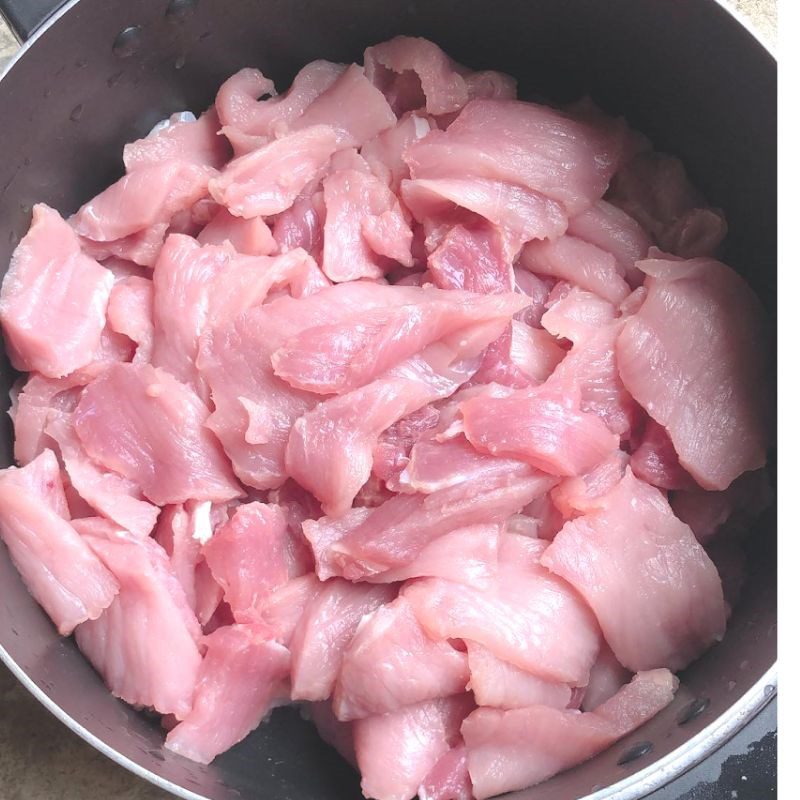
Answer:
top-left (401, 177), bottom-right (567, 247)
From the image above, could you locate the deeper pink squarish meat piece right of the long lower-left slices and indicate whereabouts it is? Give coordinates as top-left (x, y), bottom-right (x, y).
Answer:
top-left (203, 502), bottom-right (305, 622)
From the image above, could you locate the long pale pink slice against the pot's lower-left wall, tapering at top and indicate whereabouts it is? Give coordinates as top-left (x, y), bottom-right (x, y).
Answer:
top-left (75, 532), bottom-right (202, 719)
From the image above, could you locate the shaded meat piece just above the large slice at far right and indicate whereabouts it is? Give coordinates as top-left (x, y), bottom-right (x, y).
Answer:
top-left (567, 200), bottom-right (653, 286)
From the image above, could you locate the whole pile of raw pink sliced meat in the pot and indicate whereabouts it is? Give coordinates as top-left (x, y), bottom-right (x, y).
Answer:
top-left (0, 38), bottom-right (770, 800)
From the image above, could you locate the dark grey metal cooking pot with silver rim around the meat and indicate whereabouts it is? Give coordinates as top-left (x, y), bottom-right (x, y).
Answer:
top-left (0, 0), bottom-right (776, 800)
